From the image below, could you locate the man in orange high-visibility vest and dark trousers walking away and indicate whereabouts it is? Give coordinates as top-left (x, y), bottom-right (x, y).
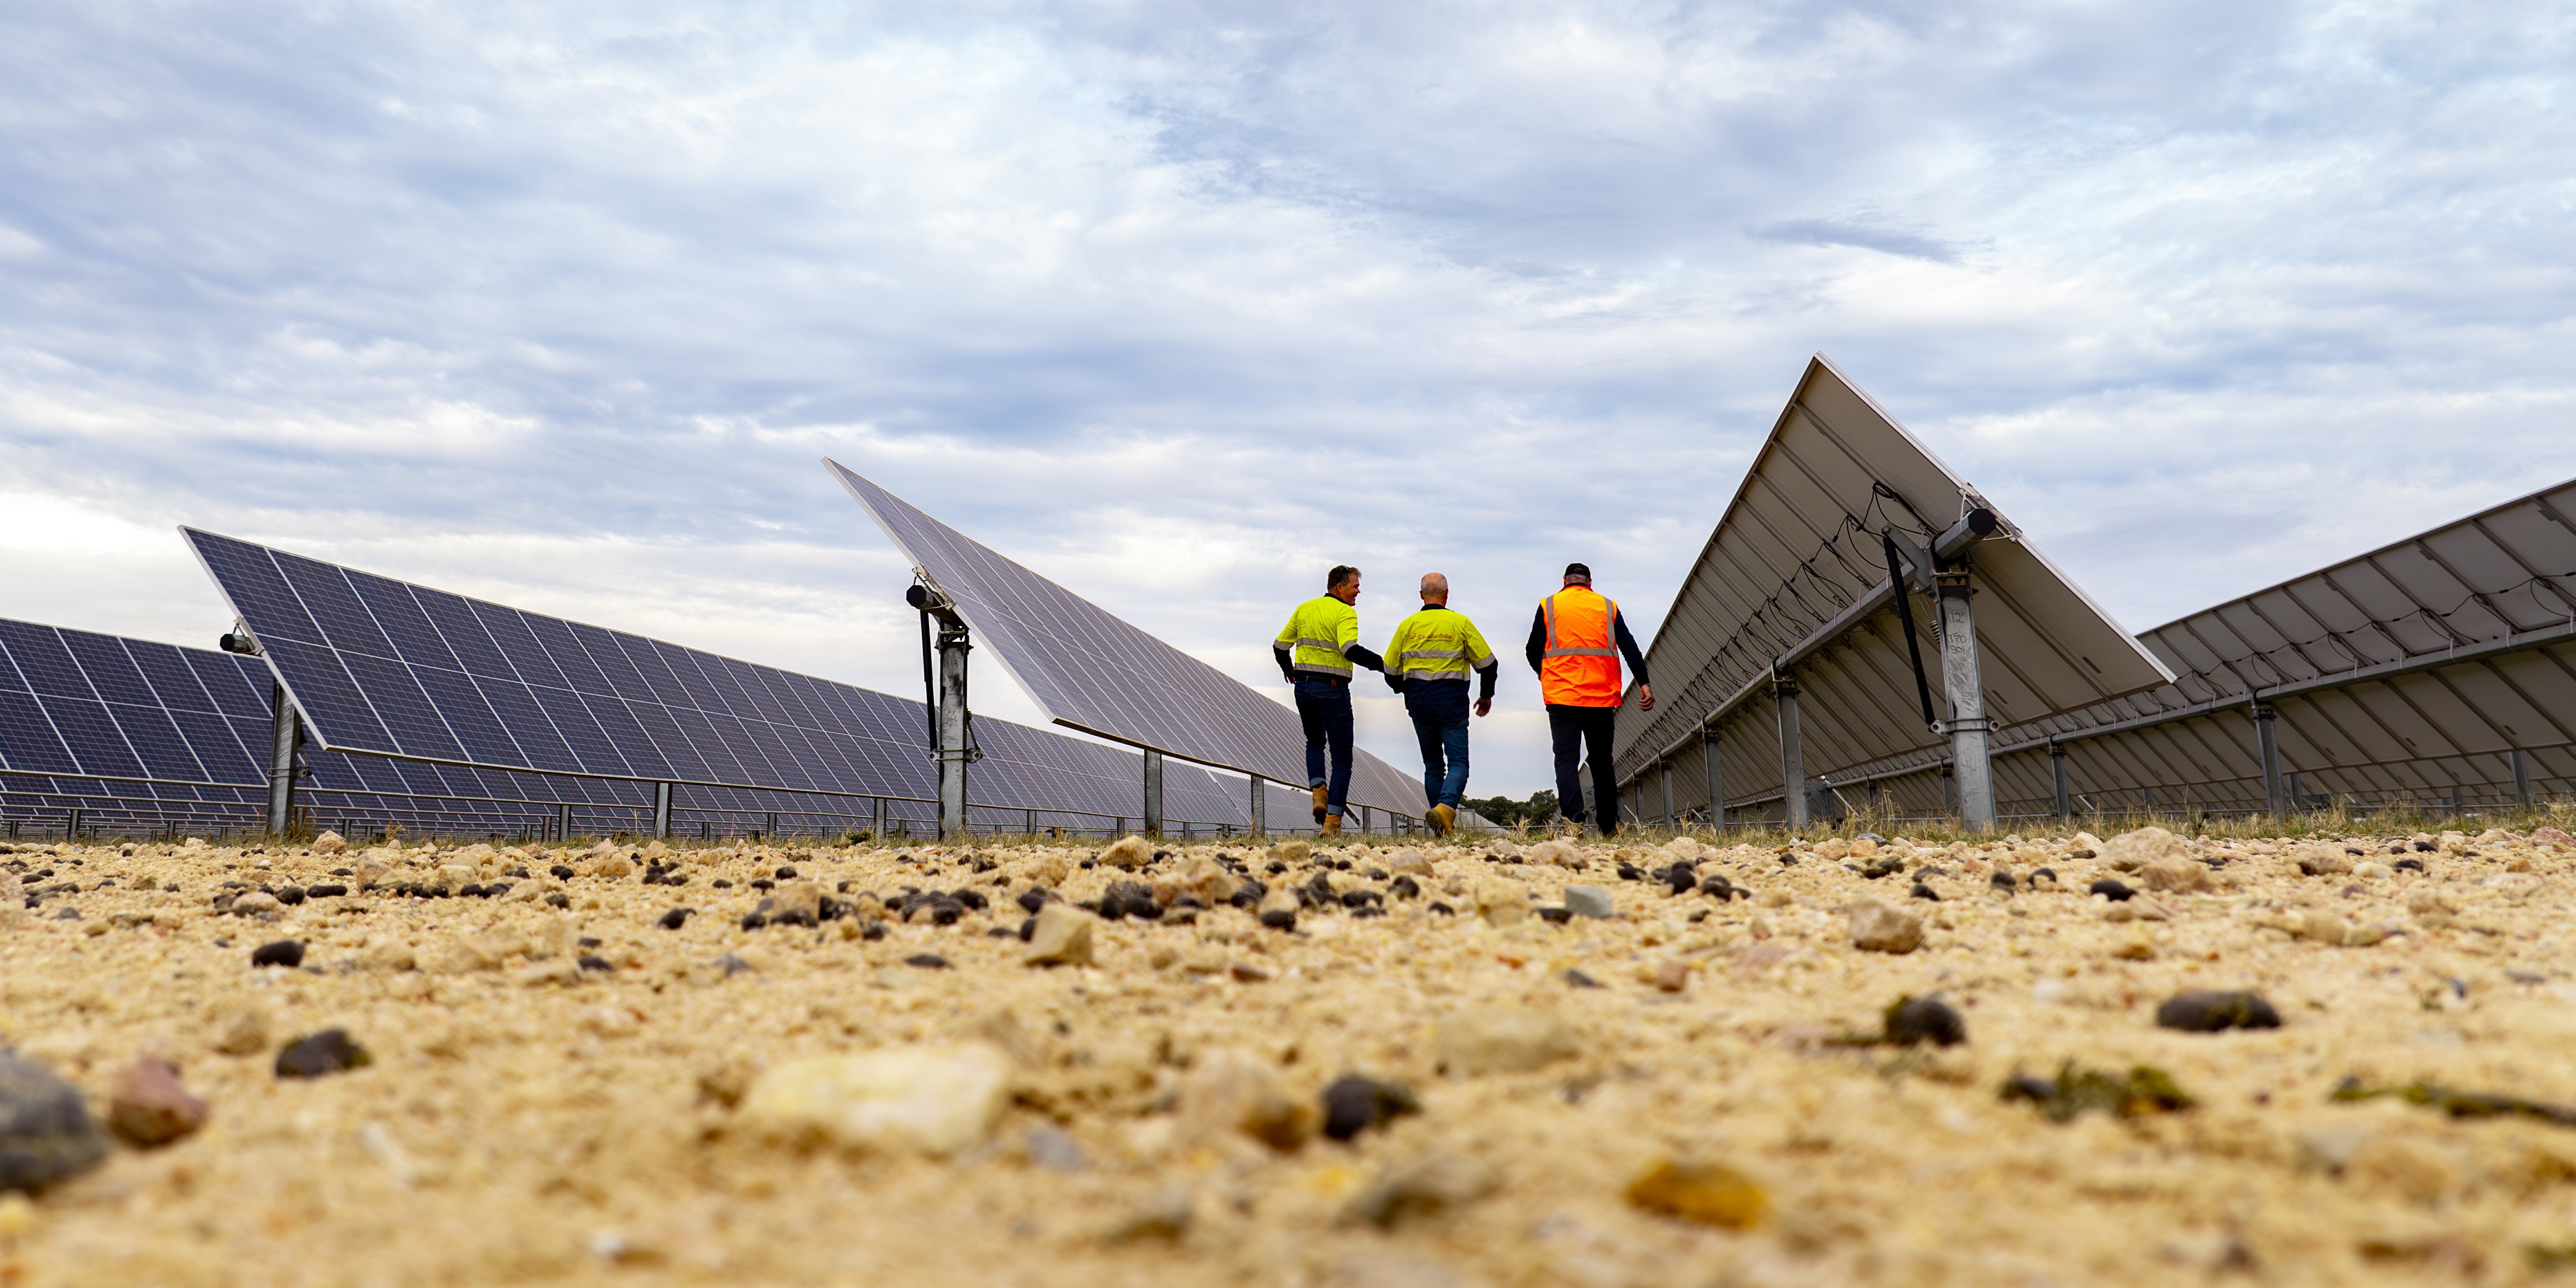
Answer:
top-left (1528, 564), bottom-right (1654, 837)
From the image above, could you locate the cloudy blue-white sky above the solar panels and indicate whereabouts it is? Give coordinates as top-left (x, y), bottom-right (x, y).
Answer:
top-left (0, 0), bottom-right (2576, 794)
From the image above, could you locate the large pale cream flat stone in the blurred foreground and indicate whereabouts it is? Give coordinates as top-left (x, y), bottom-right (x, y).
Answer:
top-left (742, 1043), bottom-right (1010, 1157)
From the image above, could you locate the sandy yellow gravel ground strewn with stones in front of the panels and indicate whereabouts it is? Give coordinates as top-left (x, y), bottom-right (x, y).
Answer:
top-left (0, 830), bottom-right (2576, 1288)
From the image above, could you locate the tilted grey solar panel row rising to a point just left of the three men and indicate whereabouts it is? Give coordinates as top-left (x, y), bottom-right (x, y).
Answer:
top-left (824, 461), bottom-right (1422, 822)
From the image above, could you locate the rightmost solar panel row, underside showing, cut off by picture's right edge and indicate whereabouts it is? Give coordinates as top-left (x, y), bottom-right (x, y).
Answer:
top-left (1947, 479), bottom-right (2576, 814)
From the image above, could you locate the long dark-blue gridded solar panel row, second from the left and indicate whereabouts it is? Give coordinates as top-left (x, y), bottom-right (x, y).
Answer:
top-left (183, 528), bottom-right (1278, 824)
